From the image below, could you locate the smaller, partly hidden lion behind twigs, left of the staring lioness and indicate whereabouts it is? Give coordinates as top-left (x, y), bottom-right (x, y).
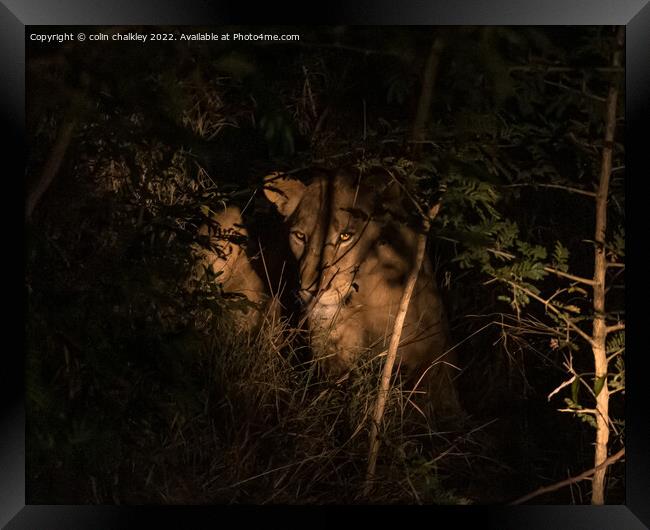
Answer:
top-left (190, 206), bottom-right (278, 331)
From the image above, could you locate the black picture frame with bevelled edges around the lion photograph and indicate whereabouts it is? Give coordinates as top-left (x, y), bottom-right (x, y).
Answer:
top-left (6, 0), bottom-right (650, 530)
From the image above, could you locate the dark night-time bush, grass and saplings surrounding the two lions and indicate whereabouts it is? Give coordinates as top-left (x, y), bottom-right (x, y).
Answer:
top-left (26, 27), bottom-right (625, 504)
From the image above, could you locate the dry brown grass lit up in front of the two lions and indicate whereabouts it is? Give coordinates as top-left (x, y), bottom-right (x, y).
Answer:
top-left (154, 296), bottom-right (474, 504)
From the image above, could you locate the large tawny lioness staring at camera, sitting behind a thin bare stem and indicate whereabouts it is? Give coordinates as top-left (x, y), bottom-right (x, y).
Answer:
top-left (265, 170), bottom-right (458, 413)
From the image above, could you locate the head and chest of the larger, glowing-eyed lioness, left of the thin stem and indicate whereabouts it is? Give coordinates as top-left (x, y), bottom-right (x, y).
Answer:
top-left (266, 172), bottom-right (422, 371)
